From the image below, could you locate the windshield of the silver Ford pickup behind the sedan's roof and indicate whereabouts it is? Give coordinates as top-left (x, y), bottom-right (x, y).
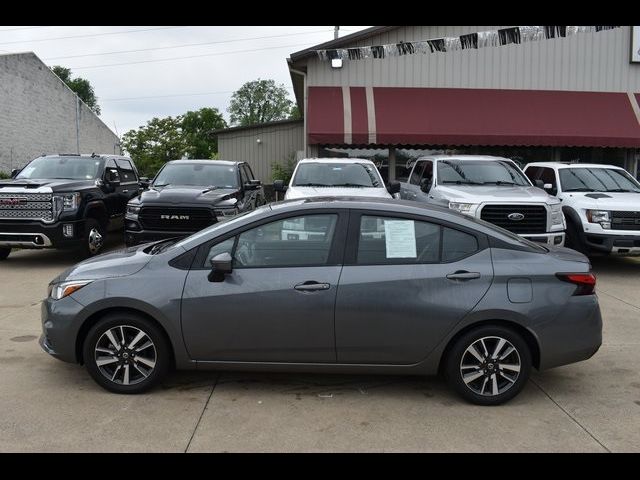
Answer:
top-left (438, 159), bottom-right (531, 187)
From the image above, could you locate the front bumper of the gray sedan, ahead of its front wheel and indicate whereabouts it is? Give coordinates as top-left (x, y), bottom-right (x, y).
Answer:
top-left (40, 296), bottom-right (84, 363)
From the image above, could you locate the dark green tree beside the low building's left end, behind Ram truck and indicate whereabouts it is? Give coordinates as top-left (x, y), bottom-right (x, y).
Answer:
top-left (180, 108), bottom-right (227, 158)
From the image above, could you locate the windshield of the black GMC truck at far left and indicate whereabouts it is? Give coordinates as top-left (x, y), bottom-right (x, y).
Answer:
top-left (16, 157), bottom-right (104, 180)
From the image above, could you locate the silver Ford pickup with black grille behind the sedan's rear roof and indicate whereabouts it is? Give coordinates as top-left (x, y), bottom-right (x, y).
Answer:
top-left (400, 155), bottom-right (566, 246)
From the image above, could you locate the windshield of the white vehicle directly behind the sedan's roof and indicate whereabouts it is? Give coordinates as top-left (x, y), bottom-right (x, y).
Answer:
top-left (291, 162), bottom-right (382, 188)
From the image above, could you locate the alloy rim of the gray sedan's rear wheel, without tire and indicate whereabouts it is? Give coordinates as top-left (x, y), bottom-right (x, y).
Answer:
top-left (460, 336), bottom-right (522, 397)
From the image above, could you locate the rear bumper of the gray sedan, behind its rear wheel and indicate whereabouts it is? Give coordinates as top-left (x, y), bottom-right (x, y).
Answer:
top-left (535, 295), bottom-right (602, 370)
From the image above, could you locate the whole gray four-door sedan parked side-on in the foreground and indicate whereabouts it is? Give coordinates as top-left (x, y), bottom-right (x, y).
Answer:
top-left (40, 198), bottom-right (602, 405)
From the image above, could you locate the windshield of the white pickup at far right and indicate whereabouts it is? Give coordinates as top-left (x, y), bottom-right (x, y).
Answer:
top-left (560, 167), bottom-right (640, 193)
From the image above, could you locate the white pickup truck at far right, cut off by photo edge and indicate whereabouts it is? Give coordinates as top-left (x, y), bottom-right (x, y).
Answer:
top-left (524, 162), bottom-right (640, 256)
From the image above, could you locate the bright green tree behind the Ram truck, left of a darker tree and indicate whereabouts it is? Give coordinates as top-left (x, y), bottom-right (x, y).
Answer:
top-left (122, 117), bottom-right (187, 177)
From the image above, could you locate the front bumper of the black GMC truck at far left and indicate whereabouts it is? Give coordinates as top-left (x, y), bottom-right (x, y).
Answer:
top-left (0, 220), bottom-right (84, 249)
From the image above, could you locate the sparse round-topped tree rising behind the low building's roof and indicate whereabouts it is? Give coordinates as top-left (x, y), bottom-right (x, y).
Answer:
top-left (227, 79), bottom-right (293, 126)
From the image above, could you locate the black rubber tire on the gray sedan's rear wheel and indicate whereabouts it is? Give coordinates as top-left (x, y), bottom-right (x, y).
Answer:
top-left (444, 325), bottom-right (531, 406)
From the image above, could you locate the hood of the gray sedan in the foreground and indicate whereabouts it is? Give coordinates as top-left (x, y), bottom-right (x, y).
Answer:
top-left (51, 244), bottom-right (153, 283)
